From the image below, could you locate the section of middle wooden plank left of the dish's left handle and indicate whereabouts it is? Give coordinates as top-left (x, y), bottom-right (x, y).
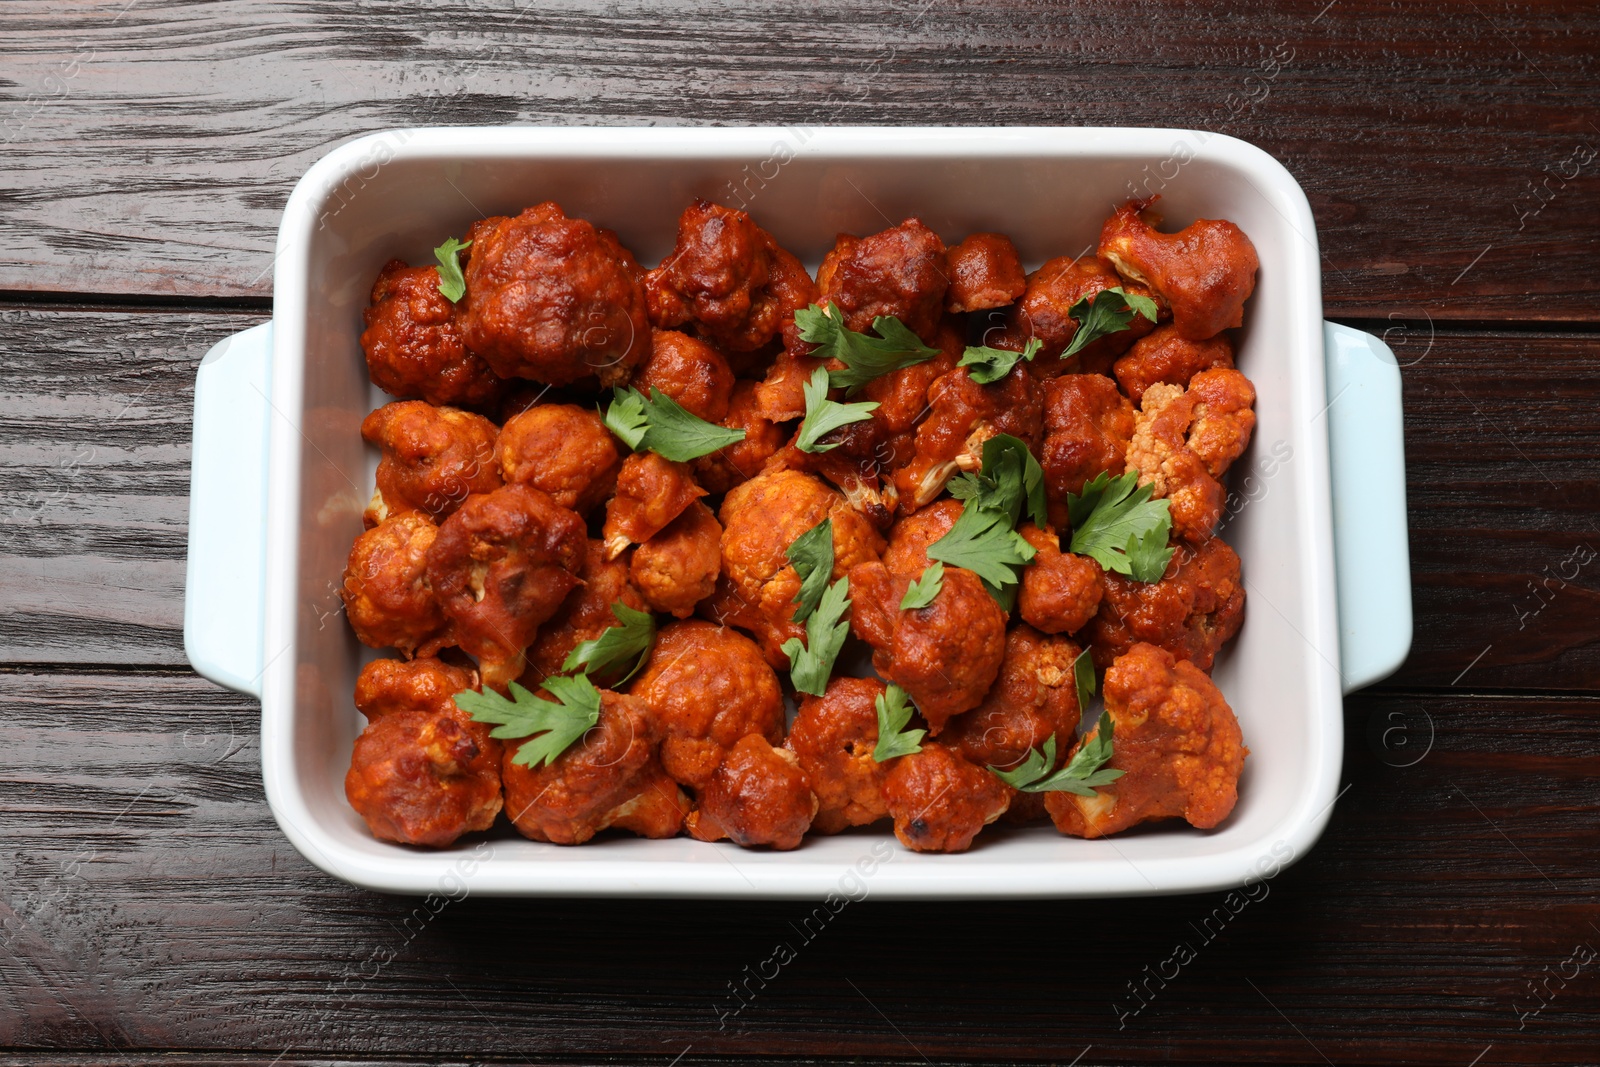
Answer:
top-left (0, 307), bottom-right (266, 664)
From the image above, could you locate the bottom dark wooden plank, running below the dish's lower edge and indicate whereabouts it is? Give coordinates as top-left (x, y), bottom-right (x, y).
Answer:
top-left (0, 672), bottom-right (1600, 1067)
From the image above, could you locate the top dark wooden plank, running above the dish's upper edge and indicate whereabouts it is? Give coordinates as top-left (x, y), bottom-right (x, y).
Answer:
top-left (0, 0), bottom-right (1600, 322)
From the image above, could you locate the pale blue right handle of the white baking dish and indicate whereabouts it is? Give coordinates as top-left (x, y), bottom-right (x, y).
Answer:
top-left (1322, 322), bottom-right (1411, 693)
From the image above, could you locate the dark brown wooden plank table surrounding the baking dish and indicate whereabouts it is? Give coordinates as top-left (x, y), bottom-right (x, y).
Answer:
top-left (0, 0), bottom-right (1600, 1067)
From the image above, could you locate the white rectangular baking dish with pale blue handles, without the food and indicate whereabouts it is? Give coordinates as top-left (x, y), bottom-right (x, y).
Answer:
top-left (184, 128), bottom-right (1411, 897)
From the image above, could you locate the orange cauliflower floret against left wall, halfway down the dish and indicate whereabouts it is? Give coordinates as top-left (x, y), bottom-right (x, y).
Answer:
top-left (339, 514), bottom-right (454, 657)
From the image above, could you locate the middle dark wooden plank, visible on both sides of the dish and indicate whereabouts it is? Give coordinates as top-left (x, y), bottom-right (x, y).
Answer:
top-left (0, 307), bottom-right (1600, 689)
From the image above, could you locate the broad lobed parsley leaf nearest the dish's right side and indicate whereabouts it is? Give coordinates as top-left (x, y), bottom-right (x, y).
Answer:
top-left (1067, 470), bottom-right (1173, 582)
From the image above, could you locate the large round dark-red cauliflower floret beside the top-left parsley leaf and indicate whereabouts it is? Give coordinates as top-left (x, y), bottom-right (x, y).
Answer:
top-left (461, 202), bottom-right (650, 386)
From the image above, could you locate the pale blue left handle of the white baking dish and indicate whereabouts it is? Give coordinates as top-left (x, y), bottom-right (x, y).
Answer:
top-left (184, 322), bottom-right (272, 697)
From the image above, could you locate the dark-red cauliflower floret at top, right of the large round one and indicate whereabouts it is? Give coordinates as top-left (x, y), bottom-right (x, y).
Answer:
top-left (645, 200), bottom-right (816, 364)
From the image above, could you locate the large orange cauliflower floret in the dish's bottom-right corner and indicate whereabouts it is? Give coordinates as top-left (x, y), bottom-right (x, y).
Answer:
top-left (1045, 643), bottom-right (1246, 837)
